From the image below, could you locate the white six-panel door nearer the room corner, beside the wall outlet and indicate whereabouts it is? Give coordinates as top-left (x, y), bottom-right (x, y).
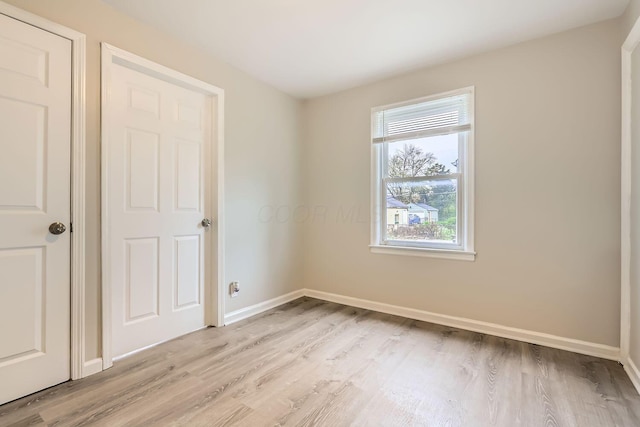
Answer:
top-left (103, 63), bottom-right (212, 357)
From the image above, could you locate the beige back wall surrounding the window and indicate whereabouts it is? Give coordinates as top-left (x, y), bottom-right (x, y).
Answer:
top-left (303, 20), bottom-right (621, 346)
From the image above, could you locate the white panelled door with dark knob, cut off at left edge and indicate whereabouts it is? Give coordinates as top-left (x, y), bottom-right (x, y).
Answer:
top-left (0, 15), bottom-right (71, 404)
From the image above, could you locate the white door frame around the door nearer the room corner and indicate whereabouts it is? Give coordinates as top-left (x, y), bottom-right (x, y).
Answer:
top-left (100, 42), bottom-right (225, 369)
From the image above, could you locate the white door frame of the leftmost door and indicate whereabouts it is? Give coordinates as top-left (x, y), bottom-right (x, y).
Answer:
top-left (0, 2), bottom-right (87, 380)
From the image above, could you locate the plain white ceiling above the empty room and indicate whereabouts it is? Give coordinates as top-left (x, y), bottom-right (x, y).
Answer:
top-left (103, 0), bottom-right (629, 98)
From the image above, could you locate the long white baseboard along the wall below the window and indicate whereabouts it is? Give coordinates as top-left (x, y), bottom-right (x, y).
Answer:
top-left (304, 289), bottom-right (620, 362)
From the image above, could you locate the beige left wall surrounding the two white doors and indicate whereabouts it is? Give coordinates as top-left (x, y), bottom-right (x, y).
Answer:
top-left (8, 0), bottom-right (302, 359)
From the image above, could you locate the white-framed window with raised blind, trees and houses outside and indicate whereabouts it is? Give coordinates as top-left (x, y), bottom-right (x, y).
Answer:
top-left (371, 87), bottom-right (475, 260)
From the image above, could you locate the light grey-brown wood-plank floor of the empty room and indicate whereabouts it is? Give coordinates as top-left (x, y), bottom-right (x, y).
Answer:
top-left (0, 298), bottom-right (640, 427)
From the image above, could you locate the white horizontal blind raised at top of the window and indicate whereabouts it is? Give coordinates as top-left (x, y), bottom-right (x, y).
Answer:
top-left (373, 92), bottom-right (472, 143)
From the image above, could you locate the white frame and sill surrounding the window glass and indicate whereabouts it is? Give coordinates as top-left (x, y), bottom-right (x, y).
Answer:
top-left (369, 86), bottom-right (476, 261)
